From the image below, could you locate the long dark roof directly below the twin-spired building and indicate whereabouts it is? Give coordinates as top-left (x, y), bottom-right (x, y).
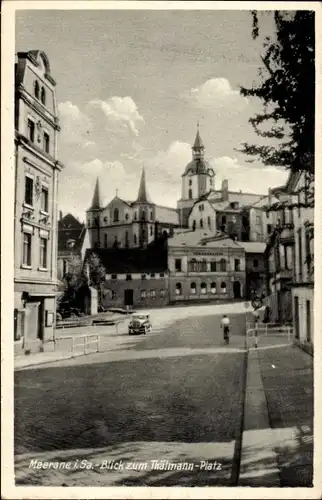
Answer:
top-left (85, 242), bottom-right (168, 274)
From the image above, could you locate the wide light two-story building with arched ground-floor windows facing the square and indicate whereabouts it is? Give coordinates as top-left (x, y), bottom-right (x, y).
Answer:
top-left (168, 229), bottom-right (245, 303)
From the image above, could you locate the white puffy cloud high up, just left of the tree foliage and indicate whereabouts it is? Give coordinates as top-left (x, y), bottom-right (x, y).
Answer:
top-left (184, 78), bottom-right (248, 110)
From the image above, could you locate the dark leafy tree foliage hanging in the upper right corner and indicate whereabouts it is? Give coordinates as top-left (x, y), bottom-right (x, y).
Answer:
top-left (240, 11), bottom-right (315, 175)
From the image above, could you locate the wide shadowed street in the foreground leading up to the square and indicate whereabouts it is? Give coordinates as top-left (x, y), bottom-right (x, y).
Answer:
top-left (15, 307), bottom-right (245, 486)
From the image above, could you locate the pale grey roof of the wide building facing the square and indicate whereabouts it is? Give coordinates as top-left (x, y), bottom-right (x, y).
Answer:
top-left (168, 229), bottom-right (241, 248)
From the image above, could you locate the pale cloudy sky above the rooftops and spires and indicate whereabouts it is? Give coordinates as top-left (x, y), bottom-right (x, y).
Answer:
top-left (16, 6), bottom-right (287, 220)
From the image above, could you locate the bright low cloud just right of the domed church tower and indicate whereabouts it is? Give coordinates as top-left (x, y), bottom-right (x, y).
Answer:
top-left (210, 156), bottom-right (288, 194)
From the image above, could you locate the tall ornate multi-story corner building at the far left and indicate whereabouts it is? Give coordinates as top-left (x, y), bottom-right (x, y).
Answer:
top-left (14, 50), bottom-right (63, 347)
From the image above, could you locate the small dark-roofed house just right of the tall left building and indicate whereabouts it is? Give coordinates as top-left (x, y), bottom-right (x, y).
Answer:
top-left (57, 212), bottom-right (90, 280)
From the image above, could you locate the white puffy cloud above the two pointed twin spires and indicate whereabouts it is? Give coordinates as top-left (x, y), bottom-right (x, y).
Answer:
top-left (88, 96), bottom-right (144, 137)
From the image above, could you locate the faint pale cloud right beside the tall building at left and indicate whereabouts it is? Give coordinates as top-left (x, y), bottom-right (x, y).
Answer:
top-left (58, 101), bottom-right (94, 147)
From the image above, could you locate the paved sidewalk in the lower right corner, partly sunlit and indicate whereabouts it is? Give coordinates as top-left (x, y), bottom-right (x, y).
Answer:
top-left (239, 346), bottom-right (313, 487)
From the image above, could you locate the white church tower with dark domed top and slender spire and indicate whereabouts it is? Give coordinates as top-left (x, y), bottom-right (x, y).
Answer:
top-left (177, 123), bottom-right (215, 226)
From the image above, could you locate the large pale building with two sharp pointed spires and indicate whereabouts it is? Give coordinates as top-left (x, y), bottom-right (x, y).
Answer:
top-left (87, 169), bottom-right (179, 248)
